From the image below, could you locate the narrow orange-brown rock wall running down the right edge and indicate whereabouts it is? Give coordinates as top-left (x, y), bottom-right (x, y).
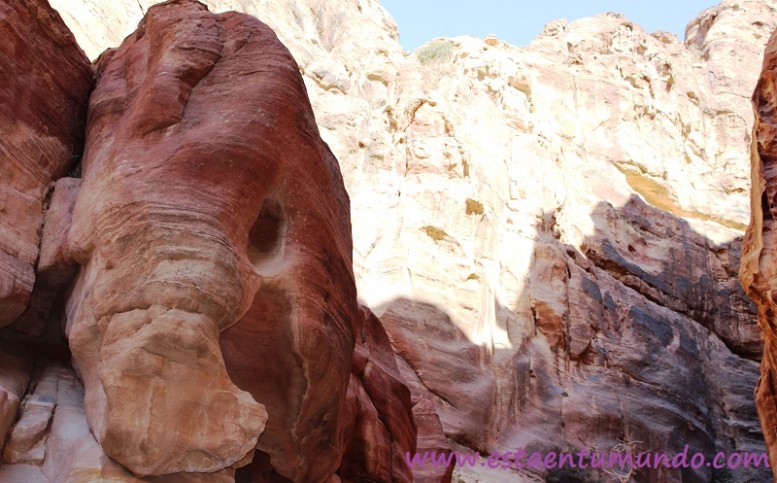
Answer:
top-left (740, 30), bottom-right (777, 481)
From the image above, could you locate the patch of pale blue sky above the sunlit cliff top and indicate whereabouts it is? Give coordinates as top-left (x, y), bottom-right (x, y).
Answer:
top-left (380, 0), bottom-right (719, 50)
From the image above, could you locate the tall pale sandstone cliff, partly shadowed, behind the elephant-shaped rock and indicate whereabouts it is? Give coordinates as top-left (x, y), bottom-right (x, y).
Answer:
top-left (0, 0), bottom-right (777, 482)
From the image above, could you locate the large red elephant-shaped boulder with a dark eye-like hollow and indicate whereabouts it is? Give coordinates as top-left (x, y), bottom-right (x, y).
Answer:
top-left (67, 0), bottom-right (358, 482)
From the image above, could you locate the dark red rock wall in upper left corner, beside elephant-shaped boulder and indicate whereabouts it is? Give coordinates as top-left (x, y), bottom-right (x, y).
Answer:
top-left (0, 0), bottom-right (92, 327)
